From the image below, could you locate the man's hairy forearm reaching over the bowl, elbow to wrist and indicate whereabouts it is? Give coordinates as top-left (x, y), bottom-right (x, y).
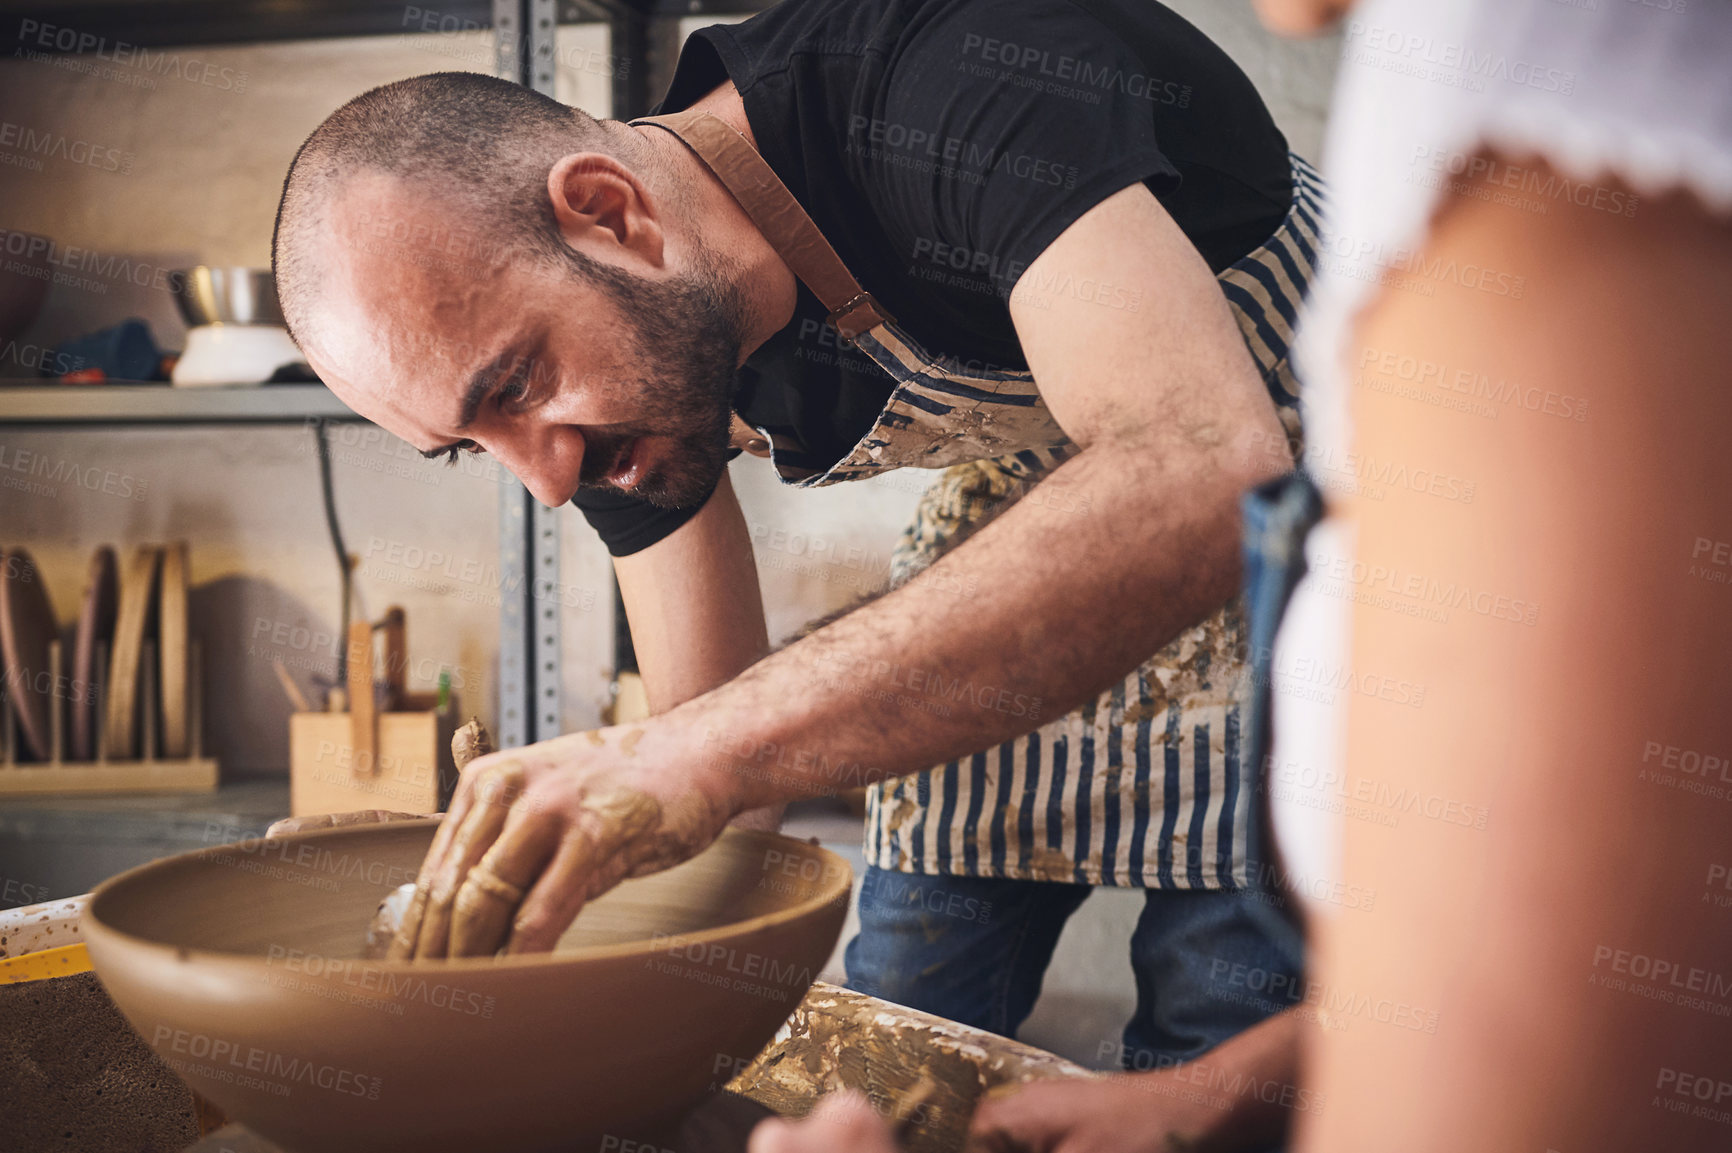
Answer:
top-left (669, 432), bottom-right (1242, 805)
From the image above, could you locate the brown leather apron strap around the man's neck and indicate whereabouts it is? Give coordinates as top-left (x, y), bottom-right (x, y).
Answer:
top-left (630, 109), bottom-right (890, 341)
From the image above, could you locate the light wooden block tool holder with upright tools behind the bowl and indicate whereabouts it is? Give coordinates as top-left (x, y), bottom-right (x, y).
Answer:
top-left (289, 608), bottom-right (457, 817)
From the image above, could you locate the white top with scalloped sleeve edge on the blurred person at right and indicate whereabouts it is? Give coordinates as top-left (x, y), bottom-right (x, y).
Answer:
top-left (1270, 0), bottom-right (1732, 914)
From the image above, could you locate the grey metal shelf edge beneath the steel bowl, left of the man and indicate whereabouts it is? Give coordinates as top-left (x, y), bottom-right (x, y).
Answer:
top-left (0, 384), bottom-right (360, 424)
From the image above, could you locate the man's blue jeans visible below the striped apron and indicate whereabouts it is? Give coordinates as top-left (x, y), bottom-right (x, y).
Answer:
top-left (847, 867), bottom-right (1301, 1070)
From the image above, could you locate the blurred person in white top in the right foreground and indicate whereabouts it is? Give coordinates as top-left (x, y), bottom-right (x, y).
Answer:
top-left (753, 0), bottom-right (1732, 1153)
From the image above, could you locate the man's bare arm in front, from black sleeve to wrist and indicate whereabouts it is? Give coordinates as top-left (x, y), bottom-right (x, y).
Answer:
top-left (661, 184), bottom-right (1290, 803)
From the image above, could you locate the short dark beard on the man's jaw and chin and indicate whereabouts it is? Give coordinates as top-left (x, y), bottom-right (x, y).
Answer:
top-left (565, 249), bottom-right (745, 509)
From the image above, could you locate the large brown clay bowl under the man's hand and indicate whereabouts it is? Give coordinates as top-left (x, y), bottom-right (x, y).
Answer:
top-left (83, 821), bottom-right (852, 1153)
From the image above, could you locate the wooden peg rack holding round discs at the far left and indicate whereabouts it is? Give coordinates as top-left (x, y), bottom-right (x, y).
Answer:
top-left (0, 641), bottom-right (218, 796)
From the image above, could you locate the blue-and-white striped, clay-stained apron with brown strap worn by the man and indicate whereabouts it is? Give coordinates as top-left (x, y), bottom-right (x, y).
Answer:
top-left (634, 111), bottom-right (1323, 888)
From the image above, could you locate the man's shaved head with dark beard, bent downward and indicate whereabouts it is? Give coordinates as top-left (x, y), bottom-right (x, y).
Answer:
top-left (275, 73), bottom-right (750, 509)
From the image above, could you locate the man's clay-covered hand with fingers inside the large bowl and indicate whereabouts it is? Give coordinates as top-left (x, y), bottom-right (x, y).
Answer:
top-left (390, 722), bottom-right (740, 959)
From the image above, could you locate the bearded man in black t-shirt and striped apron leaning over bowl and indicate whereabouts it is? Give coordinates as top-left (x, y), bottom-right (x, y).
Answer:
top-left (275, 0), bottom-right (1320, 1142)
